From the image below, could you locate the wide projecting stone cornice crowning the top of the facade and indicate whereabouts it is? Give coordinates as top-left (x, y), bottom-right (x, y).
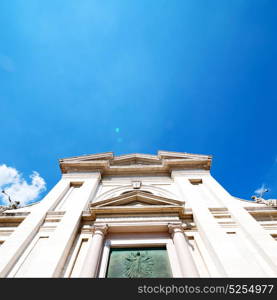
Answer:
top-left (59, 151), bottom-right (212, 175)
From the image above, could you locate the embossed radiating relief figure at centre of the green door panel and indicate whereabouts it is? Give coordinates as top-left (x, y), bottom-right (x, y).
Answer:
top-left (124, 251), bottom-right (154, 278)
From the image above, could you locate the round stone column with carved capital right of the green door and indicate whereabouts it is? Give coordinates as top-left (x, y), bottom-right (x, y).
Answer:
top-left (168, 224), bottom-right (199, 277)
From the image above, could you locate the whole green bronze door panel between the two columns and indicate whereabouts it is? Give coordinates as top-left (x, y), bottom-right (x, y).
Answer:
top-left (106, 247), bottom-right (172, 278)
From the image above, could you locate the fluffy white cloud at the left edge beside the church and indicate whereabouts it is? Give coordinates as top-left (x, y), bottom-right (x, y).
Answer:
top-left (0, 164), bottom-right (46, 206)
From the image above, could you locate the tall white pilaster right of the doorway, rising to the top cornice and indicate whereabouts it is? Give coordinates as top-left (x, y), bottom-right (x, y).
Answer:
top-left (171, 170), bottom-right (259, 277)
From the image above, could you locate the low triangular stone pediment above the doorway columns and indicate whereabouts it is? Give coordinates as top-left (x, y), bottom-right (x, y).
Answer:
top-left (91, 191), bottom-right (184, 208)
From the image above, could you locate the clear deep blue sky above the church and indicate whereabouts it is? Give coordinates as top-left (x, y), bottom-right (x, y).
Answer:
top-left (0, 0), bottom-right (277, 204)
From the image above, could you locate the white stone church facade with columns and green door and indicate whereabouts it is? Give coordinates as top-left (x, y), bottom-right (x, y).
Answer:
top-left (0, 151), bottom-right (277, 278)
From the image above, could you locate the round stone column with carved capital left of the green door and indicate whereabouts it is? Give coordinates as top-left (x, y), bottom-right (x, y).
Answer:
top-left (80, 225), bottom-right (108, 278)
